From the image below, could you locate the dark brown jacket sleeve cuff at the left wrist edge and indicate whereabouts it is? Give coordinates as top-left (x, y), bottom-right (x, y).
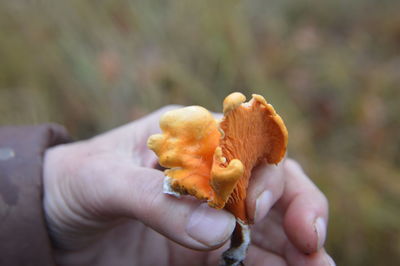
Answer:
top-left (0, 124), bottom-right (70, 265)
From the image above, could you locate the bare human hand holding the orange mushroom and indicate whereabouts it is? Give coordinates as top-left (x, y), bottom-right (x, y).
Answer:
top-left (44, 107), bottom-right (333, 266)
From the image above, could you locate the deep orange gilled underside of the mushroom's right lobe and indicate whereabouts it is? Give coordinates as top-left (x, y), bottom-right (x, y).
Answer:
top-left (211, 93), bottom-right (288, 223)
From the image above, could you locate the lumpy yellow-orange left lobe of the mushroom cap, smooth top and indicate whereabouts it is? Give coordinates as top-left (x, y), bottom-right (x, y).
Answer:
top-left (147, 106), bottom-right (221, 200)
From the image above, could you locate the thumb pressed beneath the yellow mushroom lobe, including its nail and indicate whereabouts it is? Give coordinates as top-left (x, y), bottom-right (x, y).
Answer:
top-left (103, 164), bottom-right (235, 250)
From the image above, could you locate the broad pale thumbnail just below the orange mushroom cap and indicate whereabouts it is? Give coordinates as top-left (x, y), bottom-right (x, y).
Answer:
top-left (186, 204), bottom-right (236, 247)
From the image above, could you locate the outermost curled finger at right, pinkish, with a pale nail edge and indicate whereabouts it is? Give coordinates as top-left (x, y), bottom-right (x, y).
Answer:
top-left (277, 159), bottom-right (328, 254)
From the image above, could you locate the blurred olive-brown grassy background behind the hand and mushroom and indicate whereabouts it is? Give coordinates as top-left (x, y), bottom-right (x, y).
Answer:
top-left (0, 0), bottom-right (400, 265)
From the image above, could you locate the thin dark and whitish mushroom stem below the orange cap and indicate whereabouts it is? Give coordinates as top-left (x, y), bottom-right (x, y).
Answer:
top-left (220, 220), bottom-right (250, 266)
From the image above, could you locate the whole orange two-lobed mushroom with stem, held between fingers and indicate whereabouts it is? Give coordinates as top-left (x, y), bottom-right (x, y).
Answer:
top-left (147, 92), bottom-right (288, 265)
